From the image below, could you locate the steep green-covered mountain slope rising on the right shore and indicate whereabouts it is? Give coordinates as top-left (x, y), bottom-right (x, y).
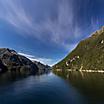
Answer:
top-left (53, 27), bottom-right (104, 70)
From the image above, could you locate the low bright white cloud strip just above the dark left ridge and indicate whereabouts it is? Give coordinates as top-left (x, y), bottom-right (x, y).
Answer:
top-left (18, 52), bottom-right (55, 66)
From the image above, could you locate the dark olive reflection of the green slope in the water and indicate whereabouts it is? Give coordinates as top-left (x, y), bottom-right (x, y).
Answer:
top-left (54, 71), bottom-right (104, 104)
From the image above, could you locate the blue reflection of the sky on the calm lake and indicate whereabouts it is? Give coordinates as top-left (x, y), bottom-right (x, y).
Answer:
top-left (0, 73), bottom-right (85, 104)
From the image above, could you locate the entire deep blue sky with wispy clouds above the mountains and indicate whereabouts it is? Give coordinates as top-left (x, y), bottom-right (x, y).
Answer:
top-left (0, 0), bottom-right (104, 65)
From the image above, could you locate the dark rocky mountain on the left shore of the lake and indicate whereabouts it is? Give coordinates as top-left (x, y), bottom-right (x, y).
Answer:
top-left (0, 48), bottom-right (50, 74)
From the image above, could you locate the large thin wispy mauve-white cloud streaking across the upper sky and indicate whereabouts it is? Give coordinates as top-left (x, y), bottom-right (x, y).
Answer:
top-left (0, 0), bottom-right (101, 50)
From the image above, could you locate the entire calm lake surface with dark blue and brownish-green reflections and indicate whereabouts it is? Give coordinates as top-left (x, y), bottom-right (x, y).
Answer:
top-left (0, 72), bottom-right (104, 104)
